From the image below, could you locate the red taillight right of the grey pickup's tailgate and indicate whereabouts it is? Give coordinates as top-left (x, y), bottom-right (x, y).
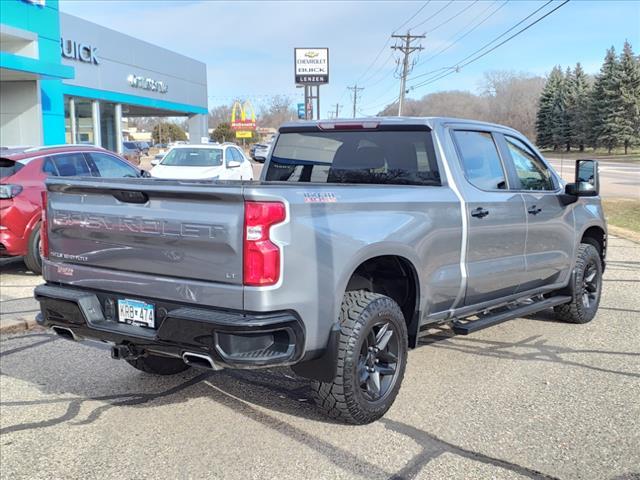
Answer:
top-left (243, 202), bottom-right (286, 286)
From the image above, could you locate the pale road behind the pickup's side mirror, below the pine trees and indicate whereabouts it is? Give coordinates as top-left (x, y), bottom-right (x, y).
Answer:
top-left (547, 158), bottom-right (640, 200)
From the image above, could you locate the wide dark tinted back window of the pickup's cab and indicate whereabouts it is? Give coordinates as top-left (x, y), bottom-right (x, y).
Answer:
top-left (266, 130), bottom-right (440, 186)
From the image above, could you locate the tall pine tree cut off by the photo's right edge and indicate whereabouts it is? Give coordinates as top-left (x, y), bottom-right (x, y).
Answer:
top-left (620, 42), bottom-right (640, 154)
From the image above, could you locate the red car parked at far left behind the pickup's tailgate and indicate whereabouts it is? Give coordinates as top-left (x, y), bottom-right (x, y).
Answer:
top-left (0, 145), bottom-right (148, 273)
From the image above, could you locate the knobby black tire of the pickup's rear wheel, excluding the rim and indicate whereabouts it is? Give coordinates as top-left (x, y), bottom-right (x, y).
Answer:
top-left (312, 290), bottom-right (408, 425)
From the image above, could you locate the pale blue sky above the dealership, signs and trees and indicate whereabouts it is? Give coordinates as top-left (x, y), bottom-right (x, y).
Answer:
top-left (60, 0), bottom-right (640, 116)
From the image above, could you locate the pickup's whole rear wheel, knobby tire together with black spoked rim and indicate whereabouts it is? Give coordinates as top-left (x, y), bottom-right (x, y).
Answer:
top-left (313, 290), bottom-right (408, 425)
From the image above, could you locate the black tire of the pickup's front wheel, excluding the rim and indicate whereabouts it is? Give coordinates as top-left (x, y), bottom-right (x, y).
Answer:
top-left (553, 243), bottom-right (602, 323)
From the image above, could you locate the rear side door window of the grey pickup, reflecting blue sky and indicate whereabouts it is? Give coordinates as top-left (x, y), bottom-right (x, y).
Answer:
top-left (453, 130), bottom-right (507, 190)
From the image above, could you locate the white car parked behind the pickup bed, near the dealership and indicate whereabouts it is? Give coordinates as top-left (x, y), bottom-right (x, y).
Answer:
top-left (149, 144), bottom-right (253, 180)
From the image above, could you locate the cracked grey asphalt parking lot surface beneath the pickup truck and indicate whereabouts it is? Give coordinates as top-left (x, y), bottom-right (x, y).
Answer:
top-left (0, 234), bottom-right (640, 479)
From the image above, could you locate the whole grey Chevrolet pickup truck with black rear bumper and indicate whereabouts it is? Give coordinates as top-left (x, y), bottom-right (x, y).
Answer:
top-left (35, 118), bottom-right (607, 424)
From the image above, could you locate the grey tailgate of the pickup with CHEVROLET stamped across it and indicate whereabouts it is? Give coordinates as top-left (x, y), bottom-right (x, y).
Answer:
top-left (47, 178), bottom-right (244, 286)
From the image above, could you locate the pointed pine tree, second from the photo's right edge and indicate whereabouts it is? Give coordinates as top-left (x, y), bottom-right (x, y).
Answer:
top-left (591, 47), bottom-right (624, 153)
